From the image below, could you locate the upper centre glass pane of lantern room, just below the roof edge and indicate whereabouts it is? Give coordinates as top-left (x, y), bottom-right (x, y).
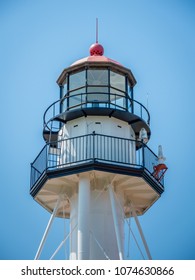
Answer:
top-left (87, 69), bottom-right (108, 86)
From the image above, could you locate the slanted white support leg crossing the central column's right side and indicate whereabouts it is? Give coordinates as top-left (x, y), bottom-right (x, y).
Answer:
top-left (108, 185), bottom-right (123, 260)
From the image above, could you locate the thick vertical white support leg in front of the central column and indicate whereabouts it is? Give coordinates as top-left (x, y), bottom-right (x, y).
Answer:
top-left (78, 174), bottom-right (90, 260)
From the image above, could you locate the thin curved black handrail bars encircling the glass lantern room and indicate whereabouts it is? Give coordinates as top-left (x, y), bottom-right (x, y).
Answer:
top-left (43, 92), bottom-right (150, 135)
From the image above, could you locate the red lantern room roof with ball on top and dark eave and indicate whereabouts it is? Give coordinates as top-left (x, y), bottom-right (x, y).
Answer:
top-left (57, 42), bottom-right (136, 86)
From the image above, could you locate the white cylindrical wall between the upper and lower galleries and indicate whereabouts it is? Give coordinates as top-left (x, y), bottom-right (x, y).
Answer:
top-left (59, 116), bottom-right (136, 165)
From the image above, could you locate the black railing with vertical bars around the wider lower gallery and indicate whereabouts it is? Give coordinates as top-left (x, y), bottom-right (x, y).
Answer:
top-left (31, 133), bottom-right (163, 188)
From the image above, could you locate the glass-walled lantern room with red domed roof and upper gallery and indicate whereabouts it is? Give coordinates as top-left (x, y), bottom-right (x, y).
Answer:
top-left (43, 43), bottom-right (151, 148)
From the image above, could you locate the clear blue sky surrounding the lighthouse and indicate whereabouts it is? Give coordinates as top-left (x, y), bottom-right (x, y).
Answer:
top-left (0, 0), bottom-right (195, 259)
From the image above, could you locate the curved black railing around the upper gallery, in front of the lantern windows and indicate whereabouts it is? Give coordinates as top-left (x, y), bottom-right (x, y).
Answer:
top-left (43, 92), bottom-right (150, 135)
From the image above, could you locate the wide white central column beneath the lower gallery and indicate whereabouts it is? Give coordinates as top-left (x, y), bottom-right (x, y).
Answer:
top-left (70, 172), bottom-right (124, 260)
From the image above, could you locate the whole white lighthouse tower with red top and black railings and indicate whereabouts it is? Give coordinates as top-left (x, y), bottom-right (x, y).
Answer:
top-left (30, 42), bottom-right (167, 260)
